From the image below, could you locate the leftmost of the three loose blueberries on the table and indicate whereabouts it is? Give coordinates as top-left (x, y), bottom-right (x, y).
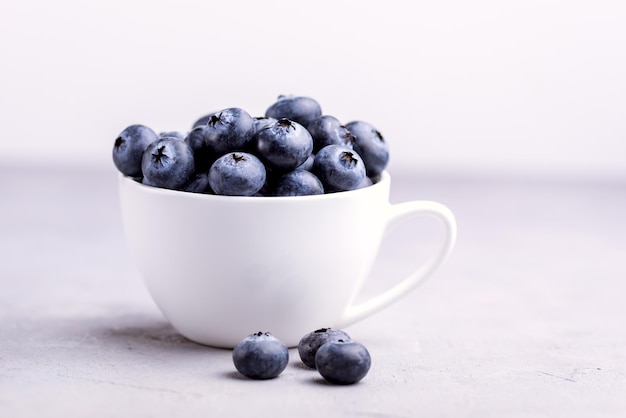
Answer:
top-left (233, 332), bottom-right (289, 379)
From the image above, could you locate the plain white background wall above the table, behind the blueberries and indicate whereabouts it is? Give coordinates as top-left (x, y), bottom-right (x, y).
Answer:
top-left (0, 0), bottom-right (626, 179)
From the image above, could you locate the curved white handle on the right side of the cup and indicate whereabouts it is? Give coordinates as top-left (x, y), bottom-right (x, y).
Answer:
top-left (338, 200), bottom-right (457, 326)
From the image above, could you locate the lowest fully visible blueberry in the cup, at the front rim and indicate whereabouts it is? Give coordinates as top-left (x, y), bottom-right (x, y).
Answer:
top-left (209, 152), bottom-right (267, 196)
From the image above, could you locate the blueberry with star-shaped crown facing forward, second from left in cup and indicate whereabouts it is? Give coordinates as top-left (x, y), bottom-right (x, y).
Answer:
top-left (141, 137), bottom-right (195, 190)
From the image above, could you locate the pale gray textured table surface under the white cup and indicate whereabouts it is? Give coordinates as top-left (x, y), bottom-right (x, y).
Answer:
top-left (0, 165), bottom-right (626, 417)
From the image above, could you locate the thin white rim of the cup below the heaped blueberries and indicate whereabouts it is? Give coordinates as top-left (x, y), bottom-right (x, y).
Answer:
top-left (119, 170), bottom-right (391, 202)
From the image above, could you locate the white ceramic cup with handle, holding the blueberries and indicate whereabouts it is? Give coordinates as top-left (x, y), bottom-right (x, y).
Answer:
top-left (119, 172), bottom-right (456, 348)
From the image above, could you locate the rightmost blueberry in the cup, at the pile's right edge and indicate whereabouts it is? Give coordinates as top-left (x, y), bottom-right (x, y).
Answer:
top-left (346, 121), bottom-right (389, 177)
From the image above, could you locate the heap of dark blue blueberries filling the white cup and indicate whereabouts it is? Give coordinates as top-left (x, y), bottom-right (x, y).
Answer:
top-left (113, 95), bottom-right (389, 196)
